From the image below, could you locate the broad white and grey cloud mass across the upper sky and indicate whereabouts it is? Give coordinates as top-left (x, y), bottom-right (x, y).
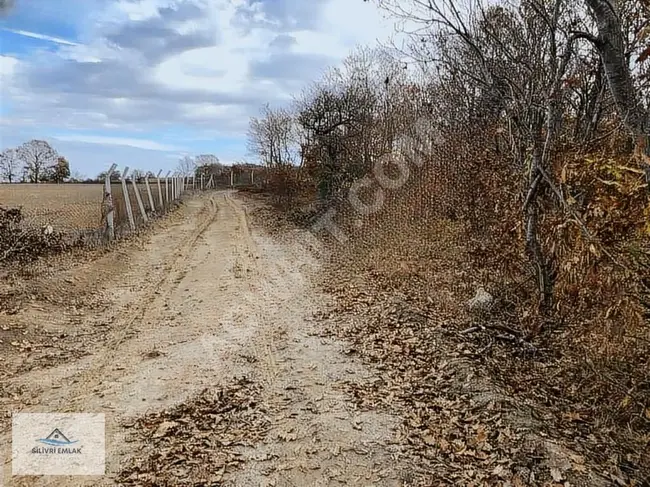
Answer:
top-left (0, 0), bottom-right (410, 161)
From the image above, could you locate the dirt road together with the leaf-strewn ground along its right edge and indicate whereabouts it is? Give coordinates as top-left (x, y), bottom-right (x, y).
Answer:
top-left (0, 191), bottom-right (632, 487)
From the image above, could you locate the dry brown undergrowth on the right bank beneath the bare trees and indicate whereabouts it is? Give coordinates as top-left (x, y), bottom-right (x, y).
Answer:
top-left (254, 134), bottom-right (650, 485)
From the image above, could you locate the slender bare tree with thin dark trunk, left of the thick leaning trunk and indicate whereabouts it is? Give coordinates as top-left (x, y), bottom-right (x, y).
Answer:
top-left (372, 0), bottom-right (596, 313)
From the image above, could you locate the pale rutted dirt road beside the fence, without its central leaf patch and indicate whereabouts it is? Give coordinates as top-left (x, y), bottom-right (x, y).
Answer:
top-left (1, 192), bottom-right (407, 486)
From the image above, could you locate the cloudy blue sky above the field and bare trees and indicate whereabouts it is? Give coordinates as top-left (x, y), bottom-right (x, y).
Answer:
top-left (0, 0), bottom-right (395, 176)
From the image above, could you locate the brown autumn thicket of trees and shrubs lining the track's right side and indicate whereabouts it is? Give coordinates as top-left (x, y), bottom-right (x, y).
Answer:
top-left (247, 0), bottom-right (650, 480)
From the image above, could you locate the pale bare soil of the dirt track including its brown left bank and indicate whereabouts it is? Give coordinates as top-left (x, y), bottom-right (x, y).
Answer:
top-left (0, 192), bottom-right (410, 486)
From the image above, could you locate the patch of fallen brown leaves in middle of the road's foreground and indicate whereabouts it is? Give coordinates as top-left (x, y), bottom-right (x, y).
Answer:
top-left (118, 378), bottom-right (269, 487)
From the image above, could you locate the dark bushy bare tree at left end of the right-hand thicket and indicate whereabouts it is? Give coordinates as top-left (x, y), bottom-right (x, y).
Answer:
top-left (296, 48), bottom-right (413, 199)
